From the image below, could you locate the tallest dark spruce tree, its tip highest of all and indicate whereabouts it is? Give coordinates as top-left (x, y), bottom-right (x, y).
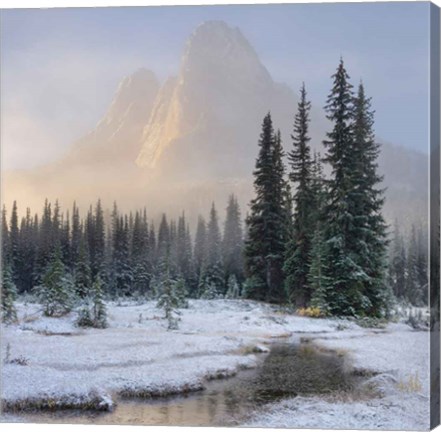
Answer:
top-left (323, 60), bottom-right (370, 316)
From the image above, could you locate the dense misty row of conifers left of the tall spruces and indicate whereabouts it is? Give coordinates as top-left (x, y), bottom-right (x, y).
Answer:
top-left (2, 195), bottom-right (244, 298)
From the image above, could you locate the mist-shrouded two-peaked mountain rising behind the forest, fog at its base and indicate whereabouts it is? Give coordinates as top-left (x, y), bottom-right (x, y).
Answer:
top-left (3, 21), bottom-right (428, 230)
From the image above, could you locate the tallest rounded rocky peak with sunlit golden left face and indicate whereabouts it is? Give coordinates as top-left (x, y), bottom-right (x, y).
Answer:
top-left (136, 21), bottom-right (306, 180)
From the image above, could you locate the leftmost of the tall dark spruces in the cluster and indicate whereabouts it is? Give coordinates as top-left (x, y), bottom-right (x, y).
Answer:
top-left (244, 113), bottom-right (287, 302)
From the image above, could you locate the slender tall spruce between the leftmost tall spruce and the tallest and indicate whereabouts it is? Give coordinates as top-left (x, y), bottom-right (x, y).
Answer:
top-left (284, 85), bottom-right (314, 307)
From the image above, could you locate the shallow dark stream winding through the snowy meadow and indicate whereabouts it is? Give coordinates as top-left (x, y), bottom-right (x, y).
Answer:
top-left (25, 343), bottom-right (359, 426)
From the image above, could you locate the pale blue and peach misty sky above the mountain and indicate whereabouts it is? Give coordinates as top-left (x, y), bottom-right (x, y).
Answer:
top-left (1, 3), bottom-right (429, 169)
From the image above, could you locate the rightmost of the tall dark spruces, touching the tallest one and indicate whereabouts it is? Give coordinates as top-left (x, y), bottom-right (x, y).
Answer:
top-left (352, 83), bottom-right (391, 317)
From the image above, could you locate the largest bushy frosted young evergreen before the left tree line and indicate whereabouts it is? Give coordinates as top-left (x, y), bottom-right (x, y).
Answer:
top-left (35, 247), bottom-right (73, 316)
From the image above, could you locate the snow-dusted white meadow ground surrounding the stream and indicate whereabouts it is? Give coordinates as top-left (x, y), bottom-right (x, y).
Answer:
top-left (1, 300), bottom-right (429, 429)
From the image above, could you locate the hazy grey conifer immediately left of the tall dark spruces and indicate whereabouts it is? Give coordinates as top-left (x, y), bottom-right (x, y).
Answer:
top-left (222, 195), bottom-right (243, 281)
